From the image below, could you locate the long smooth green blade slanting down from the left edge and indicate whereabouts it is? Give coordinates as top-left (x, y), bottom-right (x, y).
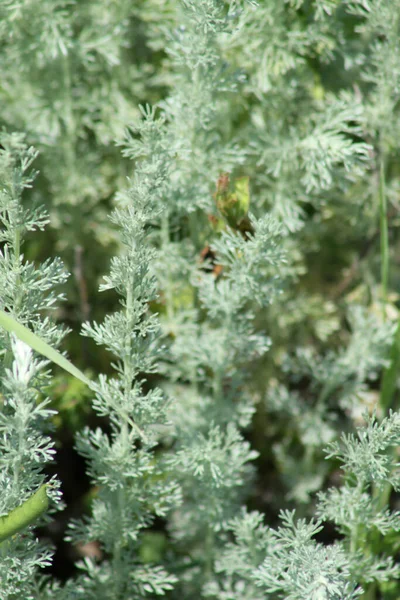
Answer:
top-left (0, 310), bottom-right (91, 387)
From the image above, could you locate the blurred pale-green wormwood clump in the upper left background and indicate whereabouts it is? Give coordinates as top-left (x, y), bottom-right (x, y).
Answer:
top-left (0, 0), bottom-right (173, 323)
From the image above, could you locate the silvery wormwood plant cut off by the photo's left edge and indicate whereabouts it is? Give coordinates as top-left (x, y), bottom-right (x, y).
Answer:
top-left (0, 133), bottom-right (66, 598)
